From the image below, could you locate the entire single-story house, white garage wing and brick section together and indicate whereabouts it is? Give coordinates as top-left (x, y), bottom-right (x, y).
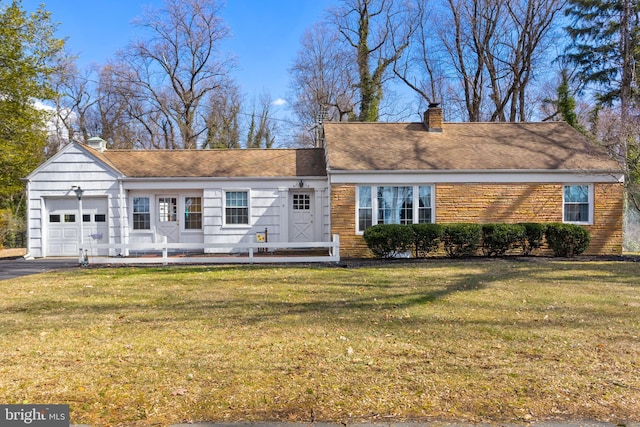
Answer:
top-left (26, 105), bottom-right (623, 257)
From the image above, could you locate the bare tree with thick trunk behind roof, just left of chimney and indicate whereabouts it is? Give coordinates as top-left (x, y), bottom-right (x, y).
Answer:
top-left (332, 0), bottom-right (422, 121)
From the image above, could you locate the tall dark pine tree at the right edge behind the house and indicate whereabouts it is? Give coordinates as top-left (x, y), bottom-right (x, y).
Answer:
top-left (566, 0), bottom-right (640, 210)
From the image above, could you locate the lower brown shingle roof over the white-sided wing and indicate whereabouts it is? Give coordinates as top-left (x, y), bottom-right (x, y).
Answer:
top-left (83, 146), bottom-right (327, 178)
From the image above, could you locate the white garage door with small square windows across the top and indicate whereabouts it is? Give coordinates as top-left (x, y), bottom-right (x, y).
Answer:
top-left (45, 198), bottom-right (108, 256)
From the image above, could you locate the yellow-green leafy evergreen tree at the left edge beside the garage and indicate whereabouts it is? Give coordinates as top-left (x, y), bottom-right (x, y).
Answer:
top-left (0, 0), bottom-right (64, 208)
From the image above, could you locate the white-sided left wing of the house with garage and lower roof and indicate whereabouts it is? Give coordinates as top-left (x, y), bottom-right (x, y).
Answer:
top-left (26, 139), bottom-right (330, 258)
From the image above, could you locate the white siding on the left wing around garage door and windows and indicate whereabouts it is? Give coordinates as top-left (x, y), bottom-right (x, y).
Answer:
top-left (28, 144), bottom-right (331, 257)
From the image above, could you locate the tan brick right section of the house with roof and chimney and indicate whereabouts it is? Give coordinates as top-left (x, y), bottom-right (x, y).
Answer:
top-left (324, 106), bottom-right (624, 256)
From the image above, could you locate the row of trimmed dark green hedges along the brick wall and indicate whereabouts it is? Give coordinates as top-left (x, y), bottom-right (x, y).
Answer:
top-left (363, 223), bottom-right (591, 258)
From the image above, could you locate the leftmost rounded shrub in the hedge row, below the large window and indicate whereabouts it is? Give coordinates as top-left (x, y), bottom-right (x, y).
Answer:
top-left (363, 224), bottom-right (414, 258)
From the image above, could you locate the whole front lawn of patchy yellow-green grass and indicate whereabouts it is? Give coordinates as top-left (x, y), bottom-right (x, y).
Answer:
top-left (0, 260), bottom-right (640, 425)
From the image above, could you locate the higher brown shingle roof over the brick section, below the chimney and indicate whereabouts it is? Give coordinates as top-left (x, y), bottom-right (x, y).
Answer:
top-left (324, 122), bottom-right (620, 172)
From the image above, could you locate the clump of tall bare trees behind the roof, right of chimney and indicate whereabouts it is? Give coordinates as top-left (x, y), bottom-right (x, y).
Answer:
top-left (394, 0), bottom-right (566, 121)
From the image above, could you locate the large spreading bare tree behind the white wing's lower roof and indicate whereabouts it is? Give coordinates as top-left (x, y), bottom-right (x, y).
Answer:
top-left (118, 0), bottom-right (233, 149)
